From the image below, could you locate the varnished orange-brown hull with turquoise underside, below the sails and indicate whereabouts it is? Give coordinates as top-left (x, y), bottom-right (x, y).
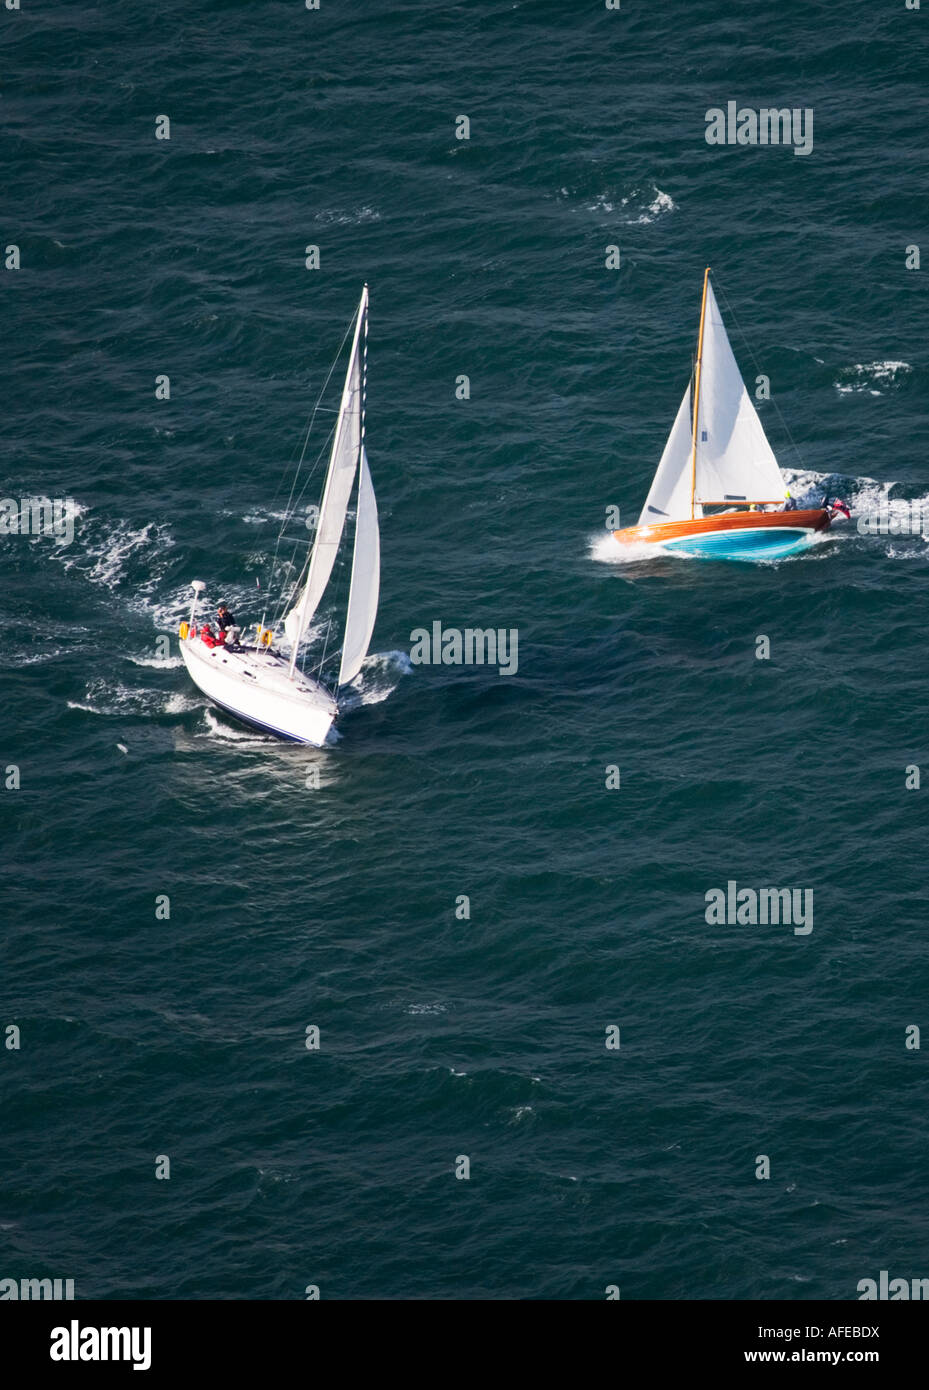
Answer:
top-left (613, 507), bottom-right (832, 560)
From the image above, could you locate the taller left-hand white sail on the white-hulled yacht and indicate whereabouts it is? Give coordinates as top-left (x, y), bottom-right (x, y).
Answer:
top-left (284, 286), bottom-right (367, 646)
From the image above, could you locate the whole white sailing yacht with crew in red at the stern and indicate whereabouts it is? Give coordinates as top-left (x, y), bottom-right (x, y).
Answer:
top-left (179, 276), bottom-right (381, 748)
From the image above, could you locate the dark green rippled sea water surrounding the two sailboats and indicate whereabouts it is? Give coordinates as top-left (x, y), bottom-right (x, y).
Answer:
top-left (0, 0), bottom-right (929, 1300)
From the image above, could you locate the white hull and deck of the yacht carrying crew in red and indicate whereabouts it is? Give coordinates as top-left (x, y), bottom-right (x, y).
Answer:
top-left (179, 637), bottom-right (338, 748)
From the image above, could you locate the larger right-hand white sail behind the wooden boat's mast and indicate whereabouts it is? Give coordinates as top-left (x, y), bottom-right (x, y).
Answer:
top-left (697, 284), bottom-right (784, 503)
